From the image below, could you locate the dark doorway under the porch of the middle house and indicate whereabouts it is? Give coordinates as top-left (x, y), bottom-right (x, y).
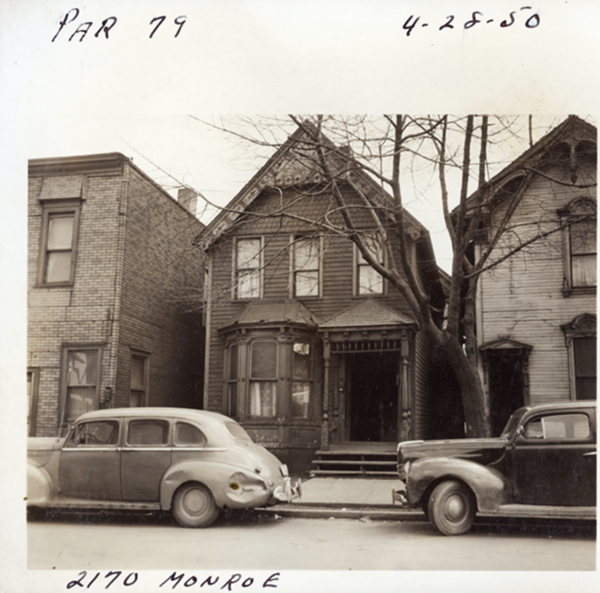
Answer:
top-left (346, 352), bottom-right (399, 442)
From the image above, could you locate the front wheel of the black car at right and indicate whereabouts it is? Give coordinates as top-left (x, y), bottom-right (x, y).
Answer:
top-left (428, 480), bottom-right (476, 535)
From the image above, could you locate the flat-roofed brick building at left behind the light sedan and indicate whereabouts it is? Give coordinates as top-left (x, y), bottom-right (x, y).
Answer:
top-left (27, 153), bottom-right (204, 436)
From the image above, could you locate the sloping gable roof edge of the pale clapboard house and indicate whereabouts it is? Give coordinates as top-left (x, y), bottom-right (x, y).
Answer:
top-left (462, 115), bottom-right (598, 212)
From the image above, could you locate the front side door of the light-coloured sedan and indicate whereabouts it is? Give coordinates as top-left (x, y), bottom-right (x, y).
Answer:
top-left (58, 420), bottom-right (121, 500)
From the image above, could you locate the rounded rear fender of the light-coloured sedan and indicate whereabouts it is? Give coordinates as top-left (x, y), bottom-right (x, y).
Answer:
top-left (160, 460), bottom-right (266, 510)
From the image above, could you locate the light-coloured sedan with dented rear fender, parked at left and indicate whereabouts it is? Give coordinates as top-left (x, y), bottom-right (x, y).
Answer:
top-left (27, 408), bottom-right (300, 527)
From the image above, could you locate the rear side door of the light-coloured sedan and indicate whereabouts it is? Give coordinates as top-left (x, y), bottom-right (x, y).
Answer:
top-left (121, 418), bottom-right (172, 502)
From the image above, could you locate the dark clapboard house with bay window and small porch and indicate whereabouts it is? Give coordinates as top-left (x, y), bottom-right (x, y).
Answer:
top-left (199, 130), bottom-right (444, 471)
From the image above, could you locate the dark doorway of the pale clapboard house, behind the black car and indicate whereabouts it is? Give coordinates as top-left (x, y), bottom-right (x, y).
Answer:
top-left (487, 349), bottom-right (525, 436)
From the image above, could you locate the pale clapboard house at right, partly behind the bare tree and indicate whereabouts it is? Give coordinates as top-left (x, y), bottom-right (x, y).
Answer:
top-left (468, 116), bottom-right (597, 435)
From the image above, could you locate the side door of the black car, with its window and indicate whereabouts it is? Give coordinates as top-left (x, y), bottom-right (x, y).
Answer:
top-left (512, 410), bottom-right (596, 506)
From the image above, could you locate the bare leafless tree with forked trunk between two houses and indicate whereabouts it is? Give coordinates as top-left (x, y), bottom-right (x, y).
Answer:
top-left (189, 115), bottom-right (595, 436)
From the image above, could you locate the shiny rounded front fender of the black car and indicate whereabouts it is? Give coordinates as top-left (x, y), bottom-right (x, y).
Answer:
top-left (407, 457), bottom-right (510, 511)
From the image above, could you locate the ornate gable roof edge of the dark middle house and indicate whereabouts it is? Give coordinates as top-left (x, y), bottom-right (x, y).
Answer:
top-left (198, 122), bottom-right (429, 249)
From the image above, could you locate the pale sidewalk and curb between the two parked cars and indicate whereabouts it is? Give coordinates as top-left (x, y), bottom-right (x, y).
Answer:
top-left (261, 478), bottom-right (425, 521)
